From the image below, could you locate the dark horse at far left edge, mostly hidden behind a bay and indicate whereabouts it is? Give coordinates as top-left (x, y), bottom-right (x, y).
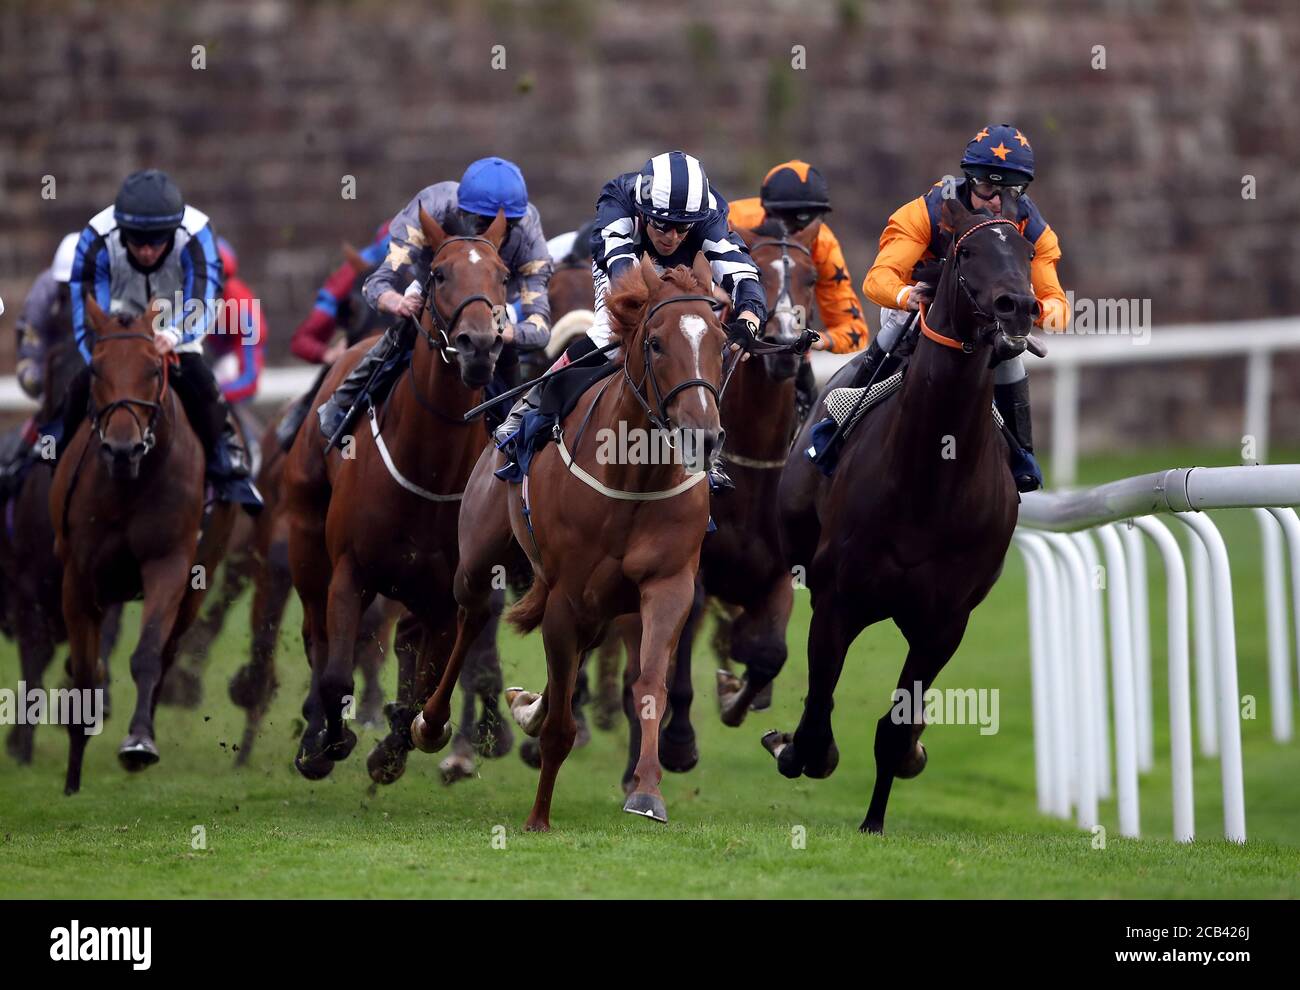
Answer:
top-left (0, 336), bottom-right (122, 764)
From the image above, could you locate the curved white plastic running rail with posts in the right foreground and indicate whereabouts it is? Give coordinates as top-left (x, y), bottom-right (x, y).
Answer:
top-left (1015, 464), bottom-right (1300, 842)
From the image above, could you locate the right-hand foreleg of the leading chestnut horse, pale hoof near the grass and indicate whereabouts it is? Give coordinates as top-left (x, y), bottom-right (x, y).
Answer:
top-left (623, 572), bottom-right (696, 821)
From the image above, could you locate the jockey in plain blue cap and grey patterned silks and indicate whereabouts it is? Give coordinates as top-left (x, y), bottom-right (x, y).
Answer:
top-left (317, 159), bottom-right (551, 438)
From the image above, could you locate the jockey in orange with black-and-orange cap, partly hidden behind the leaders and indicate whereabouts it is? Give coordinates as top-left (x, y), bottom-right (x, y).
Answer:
top-left (728, 159), bottom-right (868, 418)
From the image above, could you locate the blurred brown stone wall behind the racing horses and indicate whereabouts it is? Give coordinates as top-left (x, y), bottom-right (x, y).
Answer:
top-left (0, 0), bottom-right (1300, 450)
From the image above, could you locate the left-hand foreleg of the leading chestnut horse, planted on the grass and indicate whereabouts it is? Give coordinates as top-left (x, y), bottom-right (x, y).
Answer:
top-left (524, 595), bottom-right (579, 831)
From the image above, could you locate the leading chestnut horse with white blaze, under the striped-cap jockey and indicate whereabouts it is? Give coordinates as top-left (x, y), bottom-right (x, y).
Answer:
top-left (411, 255), bottom-right (725, 831)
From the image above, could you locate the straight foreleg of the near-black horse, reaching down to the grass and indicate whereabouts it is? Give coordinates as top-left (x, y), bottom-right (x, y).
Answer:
top-left (858, 613), bottom-right (970, 833)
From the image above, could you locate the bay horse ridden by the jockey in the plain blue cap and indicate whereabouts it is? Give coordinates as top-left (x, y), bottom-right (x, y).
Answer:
top-left (283, 209), bottom-right (508, 782)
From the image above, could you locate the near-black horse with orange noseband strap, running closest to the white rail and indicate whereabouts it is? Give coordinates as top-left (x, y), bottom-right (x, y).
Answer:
top-left (764, 200), bottom-right (1039, 833)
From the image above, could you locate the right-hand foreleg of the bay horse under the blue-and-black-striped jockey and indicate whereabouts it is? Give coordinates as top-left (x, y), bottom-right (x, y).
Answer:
top-left (118, 553), bottom-right (191, 772)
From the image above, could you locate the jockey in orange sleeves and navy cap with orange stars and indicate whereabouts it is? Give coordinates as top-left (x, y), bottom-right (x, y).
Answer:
top-left (852, 123), bottom-right (1070, 491)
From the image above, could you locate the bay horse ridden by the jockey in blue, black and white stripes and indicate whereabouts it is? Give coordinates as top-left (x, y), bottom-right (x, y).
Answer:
top-left (49, 298), bottom-right (235, 794)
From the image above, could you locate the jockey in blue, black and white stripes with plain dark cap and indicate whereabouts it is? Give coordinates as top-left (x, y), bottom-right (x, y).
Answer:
top-left (64, 169), bottom-right (263, 513)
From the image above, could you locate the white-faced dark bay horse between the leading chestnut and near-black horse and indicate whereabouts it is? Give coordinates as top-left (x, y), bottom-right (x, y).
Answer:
top-left (642, 221), bottom-right (819, 781)
